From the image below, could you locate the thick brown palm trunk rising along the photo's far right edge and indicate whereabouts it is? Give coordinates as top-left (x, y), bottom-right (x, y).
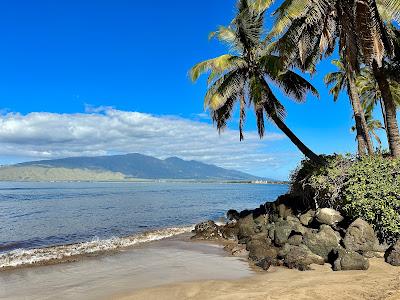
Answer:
top-left (372, 61), bottom-right (400, 157)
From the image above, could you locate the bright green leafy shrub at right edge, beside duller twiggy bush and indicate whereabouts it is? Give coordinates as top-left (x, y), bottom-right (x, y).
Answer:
top-left (343, 156), bottom-right (400, 240)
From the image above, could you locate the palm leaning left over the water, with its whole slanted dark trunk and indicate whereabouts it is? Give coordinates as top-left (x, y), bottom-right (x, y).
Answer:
top-left (190, 0), bottom-right (321, 162)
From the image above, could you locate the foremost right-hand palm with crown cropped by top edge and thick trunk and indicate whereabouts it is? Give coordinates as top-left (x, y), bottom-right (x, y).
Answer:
top-left (270, 0), bottom-right (400, 157)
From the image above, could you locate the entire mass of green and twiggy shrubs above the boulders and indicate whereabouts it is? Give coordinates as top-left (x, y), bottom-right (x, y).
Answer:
top-left (291, 155), bottom-right (400, 242)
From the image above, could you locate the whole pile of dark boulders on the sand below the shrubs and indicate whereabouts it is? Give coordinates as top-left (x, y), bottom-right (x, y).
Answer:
top-left (193, 196), bottom-right (400, 271)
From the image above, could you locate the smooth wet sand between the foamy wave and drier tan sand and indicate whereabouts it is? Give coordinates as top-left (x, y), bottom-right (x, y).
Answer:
top-left (0, 235), bottom-right (253, 300)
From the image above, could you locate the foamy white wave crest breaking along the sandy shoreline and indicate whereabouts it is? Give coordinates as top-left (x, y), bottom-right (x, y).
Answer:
top-left (0, 226), bottom-right (193, 270)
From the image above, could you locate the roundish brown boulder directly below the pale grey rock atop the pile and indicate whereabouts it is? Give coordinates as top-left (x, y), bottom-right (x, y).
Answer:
top-left (303, 225), bottom-right (340, 261)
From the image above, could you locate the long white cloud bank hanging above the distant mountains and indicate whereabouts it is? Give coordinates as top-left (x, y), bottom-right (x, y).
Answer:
top-left (0, 107), bottom-right (290, 171)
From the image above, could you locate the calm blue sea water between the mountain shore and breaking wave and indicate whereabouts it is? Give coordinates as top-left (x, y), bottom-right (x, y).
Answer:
top-left (0, 182), bottom-right (288, 253)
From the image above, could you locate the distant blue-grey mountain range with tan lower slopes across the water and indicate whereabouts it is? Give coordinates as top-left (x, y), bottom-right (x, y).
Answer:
top-left (0, 153), bottom-right (263, 180)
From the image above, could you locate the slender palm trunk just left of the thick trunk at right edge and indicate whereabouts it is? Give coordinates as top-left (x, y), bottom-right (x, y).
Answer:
top-left (348, 76), bottom-right (374, 156)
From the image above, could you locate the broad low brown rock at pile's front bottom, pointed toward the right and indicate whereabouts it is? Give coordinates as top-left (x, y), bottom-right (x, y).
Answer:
top-left (284, 245), bottom-right (325, 270)
